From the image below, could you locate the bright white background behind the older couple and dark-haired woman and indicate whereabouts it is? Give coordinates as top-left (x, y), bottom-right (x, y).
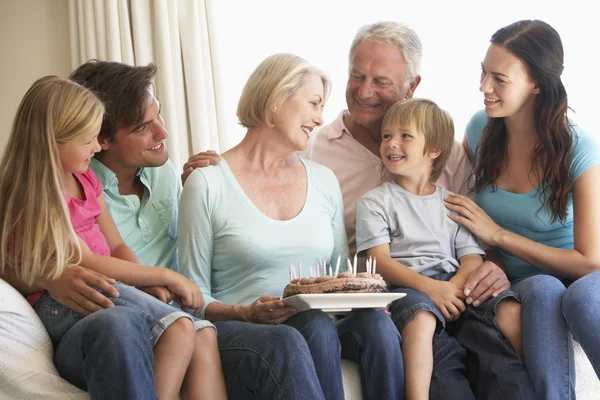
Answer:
top-left (207, 0), bottom-right (600, 151)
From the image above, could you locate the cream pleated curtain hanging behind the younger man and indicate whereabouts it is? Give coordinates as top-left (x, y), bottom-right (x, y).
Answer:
top-left (69, 0), bottom-right (221, 170)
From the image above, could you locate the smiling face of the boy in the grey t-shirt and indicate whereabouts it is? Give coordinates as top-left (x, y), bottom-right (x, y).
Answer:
top-left (380, 119), bottom-right (439, 180)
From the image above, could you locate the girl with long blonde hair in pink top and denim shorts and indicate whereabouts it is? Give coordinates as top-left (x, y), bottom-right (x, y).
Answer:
top-left (0, 76), bottom-right (226, 399)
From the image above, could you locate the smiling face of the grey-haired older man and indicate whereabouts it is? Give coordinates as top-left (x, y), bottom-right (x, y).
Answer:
top-left (346, 40), bottom-right (420, 132)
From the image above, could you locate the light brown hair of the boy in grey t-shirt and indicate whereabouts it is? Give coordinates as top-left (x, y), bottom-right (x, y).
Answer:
top-left (381, 98), bottom-right (454, 182)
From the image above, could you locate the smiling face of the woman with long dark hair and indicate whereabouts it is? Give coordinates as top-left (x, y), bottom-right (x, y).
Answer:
top-left (479, 44), bottom-right (539, 118)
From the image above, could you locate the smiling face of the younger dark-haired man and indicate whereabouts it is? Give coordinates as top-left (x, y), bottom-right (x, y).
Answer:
top-left (101, 93), bottom-right (169, 170)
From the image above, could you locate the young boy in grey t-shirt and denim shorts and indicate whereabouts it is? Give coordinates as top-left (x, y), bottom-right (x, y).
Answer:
top-left (356, 99), bottom-right (521, 400)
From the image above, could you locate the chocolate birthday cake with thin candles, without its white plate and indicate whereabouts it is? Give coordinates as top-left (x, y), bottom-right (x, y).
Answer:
top-left (283, 260), bottom-right (388, 298)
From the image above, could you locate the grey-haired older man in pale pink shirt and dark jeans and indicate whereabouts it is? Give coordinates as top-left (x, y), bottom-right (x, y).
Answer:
top-left (190, 22), bottom-right (535, 399)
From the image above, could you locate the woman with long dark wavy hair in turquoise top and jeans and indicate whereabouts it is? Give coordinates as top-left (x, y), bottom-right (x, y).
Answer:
top-left (448, 20), bottom-right (600, 399)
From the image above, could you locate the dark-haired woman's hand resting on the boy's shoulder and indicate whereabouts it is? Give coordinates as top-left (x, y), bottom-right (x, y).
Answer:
top-left (444, 193), bottom-right (504, 246)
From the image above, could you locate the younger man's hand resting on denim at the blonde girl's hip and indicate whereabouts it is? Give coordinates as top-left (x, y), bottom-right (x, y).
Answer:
top-left (45, 265), bottom-right (119, 315)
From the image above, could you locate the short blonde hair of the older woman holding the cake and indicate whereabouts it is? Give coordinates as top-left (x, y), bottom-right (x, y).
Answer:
top-left (236, 53), bottom-right (331, 128)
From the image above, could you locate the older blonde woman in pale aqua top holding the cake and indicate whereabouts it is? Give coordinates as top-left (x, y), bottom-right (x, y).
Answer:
top-left (179, 54), bottom-right (404, 399)
